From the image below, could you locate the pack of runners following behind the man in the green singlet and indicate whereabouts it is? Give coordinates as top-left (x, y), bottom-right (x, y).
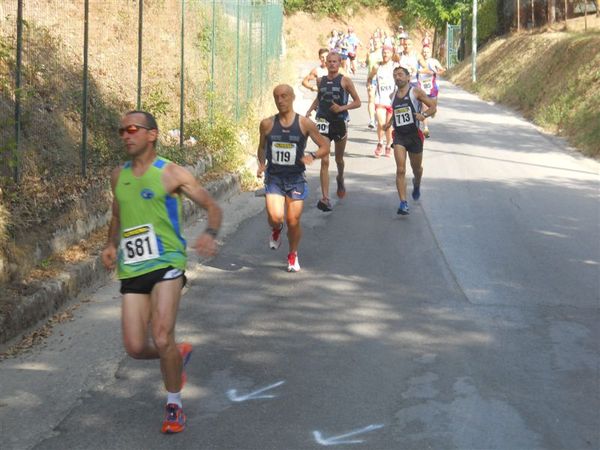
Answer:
top-left (264, 26), bottom-right (444, 272)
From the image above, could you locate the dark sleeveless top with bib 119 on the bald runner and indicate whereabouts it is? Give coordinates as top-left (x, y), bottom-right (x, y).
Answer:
top-left (265, 114), bottom-right (306, 176)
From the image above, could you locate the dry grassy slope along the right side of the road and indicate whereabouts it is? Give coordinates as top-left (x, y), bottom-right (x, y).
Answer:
top-left (450, 31), bottom-right (600, 158)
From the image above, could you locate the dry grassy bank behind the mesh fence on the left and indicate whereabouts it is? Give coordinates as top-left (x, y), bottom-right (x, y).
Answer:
top-left (0, 0), bottom-right (281, 284)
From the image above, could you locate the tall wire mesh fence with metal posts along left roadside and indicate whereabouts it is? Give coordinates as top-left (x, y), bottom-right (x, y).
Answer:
top-left (0, 0), bottom-right (283, 180)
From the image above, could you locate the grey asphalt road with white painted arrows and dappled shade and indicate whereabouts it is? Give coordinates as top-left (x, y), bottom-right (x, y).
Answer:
top-left (0, 64), bottom-right (600, 450)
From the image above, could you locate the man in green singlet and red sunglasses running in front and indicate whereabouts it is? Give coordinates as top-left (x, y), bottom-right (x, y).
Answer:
top-left (102, 111), bottom-right (222, 433)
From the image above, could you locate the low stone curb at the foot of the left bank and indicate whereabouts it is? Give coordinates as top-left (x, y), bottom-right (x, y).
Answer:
top-left (0, 174), bottom-right (240, 344)
